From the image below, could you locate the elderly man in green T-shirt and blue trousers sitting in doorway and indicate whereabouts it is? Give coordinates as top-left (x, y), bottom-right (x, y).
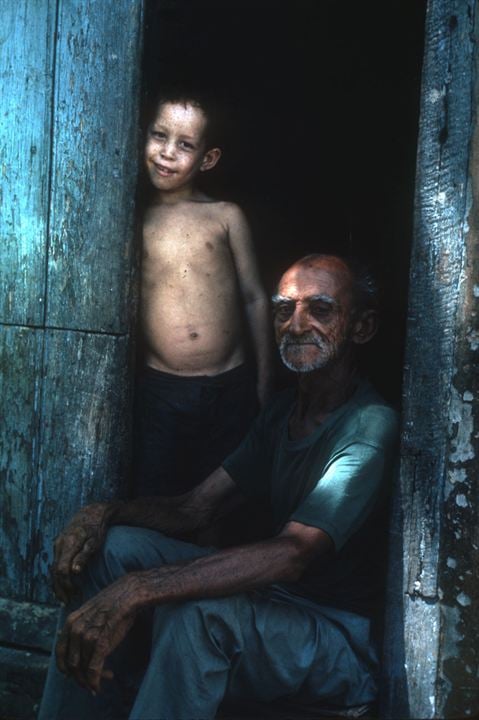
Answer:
top-left (40, 255), bottom-right (397, 720)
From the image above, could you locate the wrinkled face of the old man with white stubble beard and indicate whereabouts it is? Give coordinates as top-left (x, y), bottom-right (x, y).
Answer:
top-left (273, 257), bottom-right (353, 373)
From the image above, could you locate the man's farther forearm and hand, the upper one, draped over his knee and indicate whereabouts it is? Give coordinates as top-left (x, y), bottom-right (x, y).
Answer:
top-left (52, 467), bottom-right (242, 602)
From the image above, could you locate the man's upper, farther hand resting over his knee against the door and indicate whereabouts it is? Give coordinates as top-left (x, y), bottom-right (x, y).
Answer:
top-left (52, 503), bottom-right (119, 603)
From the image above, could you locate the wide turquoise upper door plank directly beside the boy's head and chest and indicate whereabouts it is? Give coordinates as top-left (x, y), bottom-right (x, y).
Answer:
top-left (47, 0), bottom-right (142, 332)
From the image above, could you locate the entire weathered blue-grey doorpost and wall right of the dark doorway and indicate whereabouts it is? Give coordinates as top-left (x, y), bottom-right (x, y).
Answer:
top-left (384, 0), bottom-right (479, 718)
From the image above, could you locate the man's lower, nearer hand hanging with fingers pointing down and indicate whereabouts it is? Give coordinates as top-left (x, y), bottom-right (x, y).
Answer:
top-left (56, 573), bottom-right (138, 693)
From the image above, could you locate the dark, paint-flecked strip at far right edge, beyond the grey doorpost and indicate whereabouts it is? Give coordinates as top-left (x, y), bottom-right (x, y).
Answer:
top-left (437, 11), bottom-right (479, 718)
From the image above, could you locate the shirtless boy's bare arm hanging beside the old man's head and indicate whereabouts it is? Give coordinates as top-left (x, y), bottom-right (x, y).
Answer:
top-left (228, 204), bottom-right (272, 407)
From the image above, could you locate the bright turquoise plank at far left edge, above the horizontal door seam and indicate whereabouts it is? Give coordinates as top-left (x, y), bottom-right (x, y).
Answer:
top-left (0, 0), bottom-right (56, 325)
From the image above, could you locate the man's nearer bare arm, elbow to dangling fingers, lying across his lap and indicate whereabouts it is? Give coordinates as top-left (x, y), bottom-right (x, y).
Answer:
top-left (56, 522), bottom-right (333, 692)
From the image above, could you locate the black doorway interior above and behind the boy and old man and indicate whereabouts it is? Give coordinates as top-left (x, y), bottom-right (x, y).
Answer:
top-left (143, 0), bottom-right (426, 404)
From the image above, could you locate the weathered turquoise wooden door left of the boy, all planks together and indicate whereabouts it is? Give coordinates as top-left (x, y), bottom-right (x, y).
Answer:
top-left (0, 0), bottom-right (142, 717)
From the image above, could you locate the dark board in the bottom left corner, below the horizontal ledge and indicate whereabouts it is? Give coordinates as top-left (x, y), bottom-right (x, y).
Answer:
top-left (0, 647), bottom-right (49, 720)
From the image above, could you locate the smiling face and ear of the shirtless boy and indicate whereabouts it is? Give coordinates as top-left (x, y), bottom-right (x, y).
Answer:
top-left (145, 103), bottom-right (219, 192)
